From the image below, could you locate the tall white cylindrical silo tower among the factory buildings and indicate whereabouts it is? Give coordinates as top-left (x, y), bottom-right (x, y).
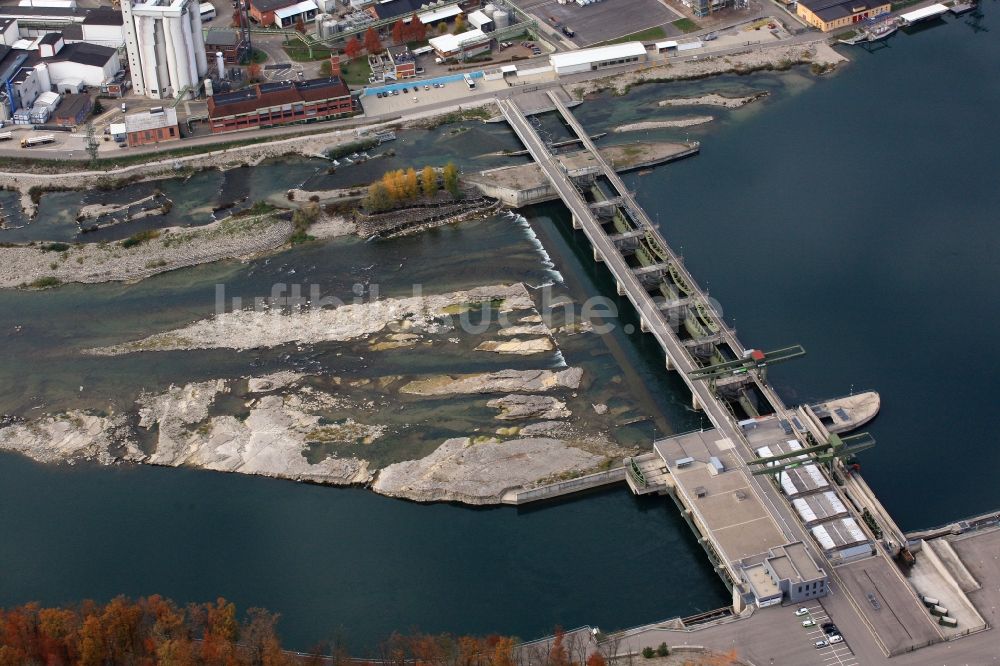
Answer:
top-left (122, 0), bottom-right (208, 99)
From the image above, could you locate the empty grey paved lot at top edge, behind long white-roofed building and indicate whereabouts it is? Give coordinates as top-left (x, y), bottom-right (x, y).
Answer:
top-left (517, 0), bottom-right (681, 46)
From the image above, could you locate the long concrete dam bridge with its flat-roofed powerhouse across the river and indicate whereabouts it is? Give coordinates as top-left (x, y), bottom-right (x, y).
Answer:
top-left (496, 92), bottom-right (964, 655)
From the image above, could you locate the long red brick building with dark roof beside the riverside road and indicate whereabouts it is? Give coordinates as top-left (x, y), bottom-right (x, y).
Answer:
top-left (208, 76), bottom-right (354, 133)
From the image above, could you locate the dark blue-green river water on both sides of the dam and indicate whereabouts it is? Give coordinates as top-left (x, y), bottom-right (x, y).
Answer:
top-left (0, 7), bottom-right (1000, 651)
